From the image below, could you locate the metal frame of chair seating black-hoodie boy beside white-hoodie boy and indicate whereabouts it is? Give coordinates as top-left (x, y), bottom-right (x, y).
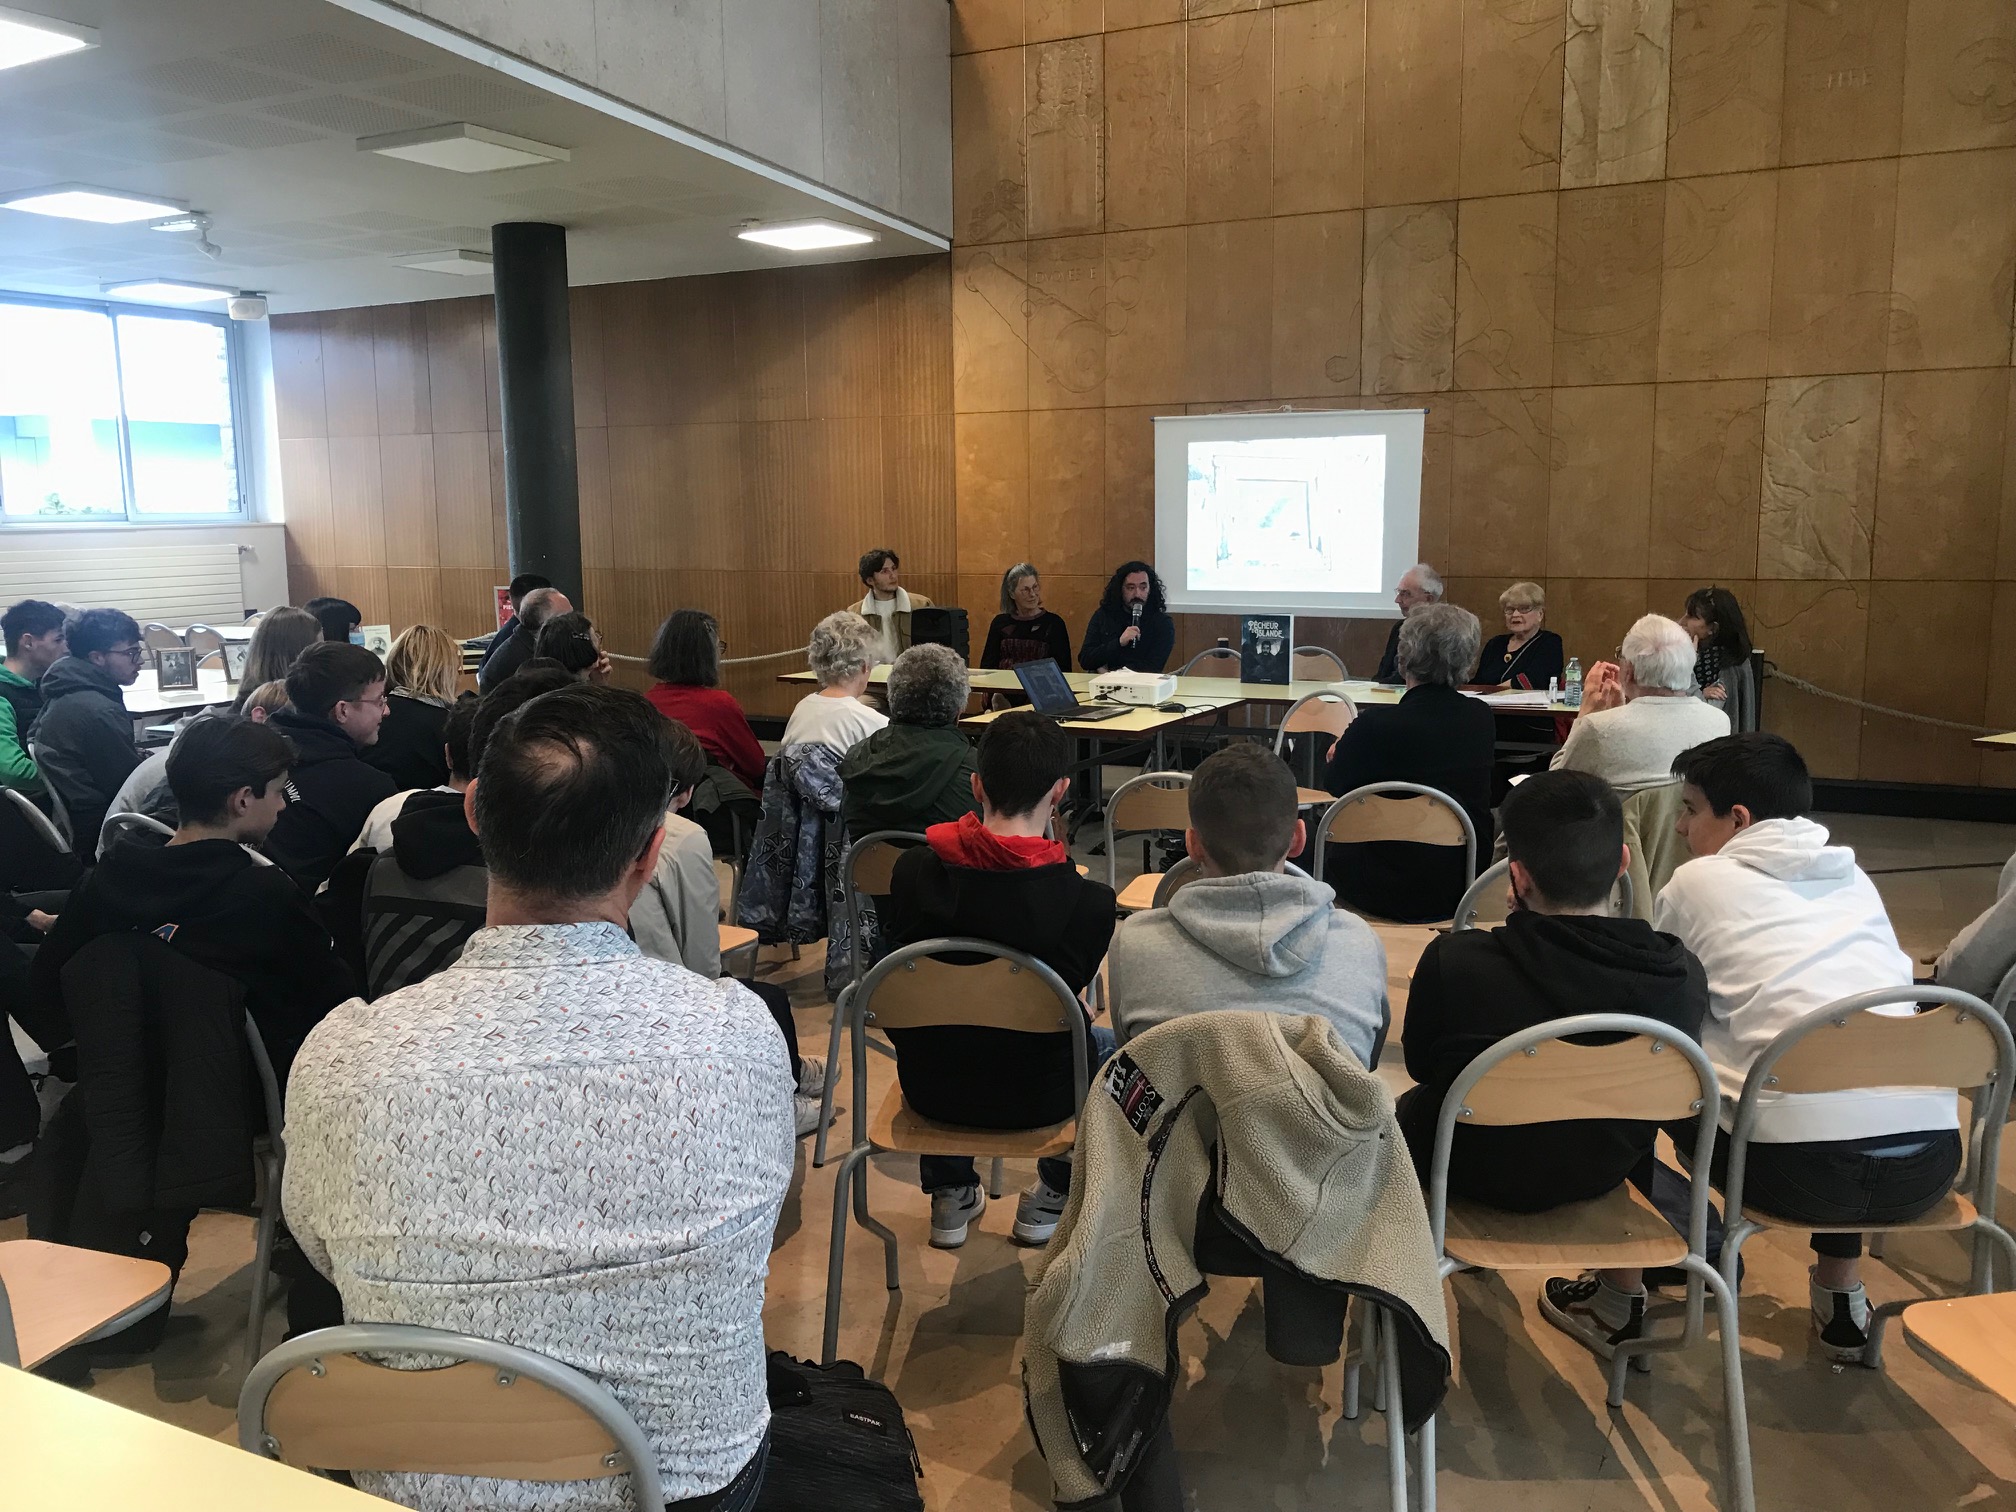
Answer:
top-left (1387, 1014), bottom-right (1756, 1512)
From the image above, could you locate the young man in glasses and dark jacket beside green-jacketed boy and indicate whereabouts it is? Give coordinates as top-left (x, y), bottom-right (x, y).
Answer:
top-left (28, 609), bottom-right (147, 855)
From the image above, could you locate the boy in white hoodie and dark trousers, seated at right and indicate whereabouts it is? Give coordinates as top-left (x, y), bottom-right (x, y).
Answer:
top-left (1546, 732), bottom-right (1962, 1361)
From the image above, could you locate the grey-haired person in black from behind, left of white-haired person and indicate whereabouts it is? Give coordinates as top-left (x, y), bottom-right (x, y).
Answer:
top-left (1322, 603), bottom-right (1498, 923)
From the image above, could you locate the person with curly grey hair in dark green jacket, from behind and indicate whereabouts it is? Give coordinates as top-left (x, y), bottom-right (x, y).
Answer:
top-left (841, 645), bottom-right (980, 841)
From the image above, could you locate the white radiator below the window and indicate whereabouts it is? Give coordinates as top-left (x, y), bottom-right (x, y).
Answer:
top-left (0, 538), bottom-right (246, 629)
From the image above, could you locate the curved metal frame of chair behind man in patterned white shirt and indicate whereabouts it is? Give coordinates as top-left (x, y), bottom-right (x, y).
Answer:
top-left (238, 1322), bottom-right (665, 1508)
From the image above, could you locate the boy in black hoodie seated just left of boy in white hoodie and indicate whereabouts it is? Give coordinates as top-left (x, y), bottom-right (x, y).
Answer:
top-left (1399, 770), bottom-right (1708, 1343)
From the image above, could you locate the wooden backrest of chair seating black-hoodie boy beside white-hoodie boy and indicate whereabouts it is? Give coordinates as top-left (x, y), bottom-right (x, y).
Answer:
top-left (1458, 1034), bottom-right (1702, 1125)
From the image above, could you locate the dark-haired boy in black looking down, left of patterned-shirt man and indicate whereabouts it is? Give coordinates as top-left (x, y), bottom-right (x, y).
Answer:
top-left (30, 713), bottom-right (353, 1306)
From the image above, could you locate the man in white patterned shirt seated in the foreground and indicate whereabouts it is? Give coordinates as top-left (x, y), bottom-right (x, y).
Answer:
top-left (284, 685), bottom-right (794, 1512)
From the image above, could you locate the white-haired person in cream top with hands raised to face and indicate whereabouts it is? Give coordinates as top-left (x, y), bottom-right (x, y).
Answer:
top-left (1552, 615), bottom-right (1730, 794)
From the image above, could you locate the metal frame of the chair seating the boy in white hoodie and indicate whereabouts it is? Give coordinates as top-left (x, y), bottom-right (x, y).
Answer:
top-left (1704, 982), bottom-right (2016, 1369)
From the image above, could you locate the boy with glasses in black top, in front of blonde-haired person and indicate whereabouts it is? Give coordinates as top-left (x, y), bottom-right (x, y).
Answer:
top-left (266, 641), bottom-right (399, 891)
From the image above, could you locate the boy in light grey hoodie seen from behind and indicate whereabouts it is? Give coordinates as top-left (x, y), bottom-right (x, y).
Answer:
top-left (1107, 744), bottom-right (1389, 1068)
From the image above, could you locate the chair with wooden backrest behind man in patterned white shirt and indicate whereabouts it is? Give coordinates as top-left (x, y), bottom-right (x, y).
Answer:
top-left (238, 1322), bottom-right (665, 1508)
